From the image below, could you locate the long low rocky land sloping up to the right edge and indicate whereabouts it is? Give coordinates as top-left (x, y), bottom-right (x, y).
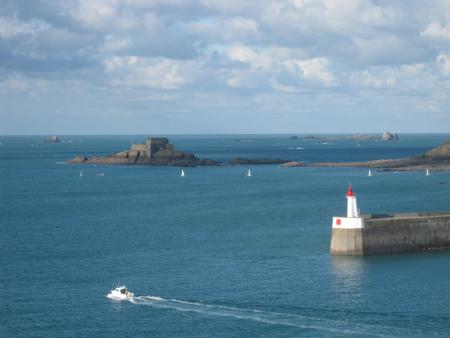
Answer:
top-left (308, 141), bottom-right (450, 171)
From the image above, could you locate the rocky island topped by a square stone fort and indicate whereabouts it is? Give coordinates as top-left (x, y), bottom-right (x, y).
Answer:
top-left (68, 137), bottom-right (219, 167)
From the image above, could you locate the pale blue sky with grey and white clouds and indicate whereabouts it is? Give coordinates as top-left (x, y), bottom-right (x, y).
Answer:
top-left (0, 0), bottom-right (450, 135)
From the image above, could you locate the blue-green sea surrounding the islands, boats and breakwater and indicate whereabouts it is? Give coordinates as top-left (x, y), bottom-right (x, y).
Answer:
top-left (0, 134), bottom-right (450, 338)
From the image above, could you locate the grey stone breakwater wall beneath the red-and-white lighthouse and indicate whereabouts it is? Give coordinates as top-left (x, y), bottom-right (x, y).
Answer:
top-left (330, 212), bottom-right (450, 255)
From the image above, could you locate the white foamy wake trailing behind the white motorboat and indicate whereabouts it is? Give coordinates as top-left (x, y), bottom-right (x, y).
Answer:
top-left (130, 296), bottom-right (422, 337)
